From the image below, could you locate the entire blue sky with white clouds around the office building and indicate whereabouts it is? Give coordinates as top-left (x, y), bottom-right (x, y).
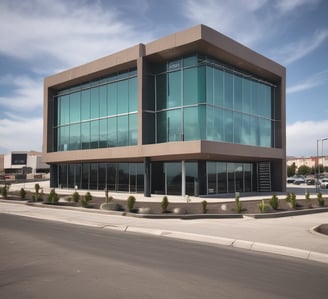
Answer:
top-left (0, 0), bottom-right (328, 157)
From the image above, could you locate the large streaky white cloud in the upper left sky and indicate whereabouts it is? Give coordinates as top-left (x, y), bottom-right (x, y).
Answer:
top-left (0, 0), bottom-right (152, 67)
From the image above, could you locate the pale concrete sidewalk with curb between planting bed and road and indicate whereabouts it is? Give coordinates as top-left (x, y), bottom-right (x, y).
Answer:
top-left (0, 200), bottom-right (328, 264)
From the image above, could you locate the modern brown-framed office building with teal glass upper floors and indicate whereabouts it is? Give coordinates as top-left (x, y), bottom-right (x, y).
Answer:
top-left (43, 25), bottom-right (286, 196)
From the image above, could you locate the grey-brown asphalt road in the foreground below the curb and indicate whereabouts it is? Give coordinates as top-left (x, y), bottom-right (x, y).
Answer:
top-left (0, 214), bottom-right (328, 299)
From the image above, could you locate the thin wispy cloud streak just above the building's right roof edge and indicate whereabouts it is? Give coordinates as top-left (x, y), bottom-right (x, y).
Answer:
top-left (273, 29), bottom-right (328, 65)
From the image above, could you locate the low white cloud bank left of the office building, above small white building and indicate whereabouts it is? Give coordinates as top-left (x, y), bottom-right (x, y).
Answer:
top-left (0, 117), bottom-right (43, 153)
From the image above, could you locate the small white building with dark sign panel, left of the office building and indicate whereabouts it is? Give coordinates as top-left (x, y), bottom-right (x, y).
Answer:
top-left (3, 151), bottom-right (49, 176)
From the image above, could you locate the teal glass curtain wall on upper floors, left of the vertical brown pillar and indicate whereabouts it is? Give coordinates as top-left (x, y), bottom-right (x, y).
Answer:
top-left (54, 70), bottom-right (138, 151)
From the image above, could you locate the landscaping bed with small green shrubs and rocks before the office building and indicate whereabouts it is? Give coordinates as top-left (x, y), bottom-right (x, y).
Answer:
top-left (1, 191), bottom-right (328, 215)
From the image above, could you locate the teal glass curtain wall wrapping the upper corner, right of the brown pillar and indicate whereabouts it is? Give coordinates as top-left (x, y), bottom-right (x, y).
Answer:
top-left (155, 55), bottom-right (276, 147)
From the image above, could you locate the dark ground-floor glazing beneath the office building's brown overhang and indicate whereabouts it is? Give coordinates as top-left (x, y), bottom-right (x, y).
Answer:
top-left (51, 160), bottom-right (257, 196)
